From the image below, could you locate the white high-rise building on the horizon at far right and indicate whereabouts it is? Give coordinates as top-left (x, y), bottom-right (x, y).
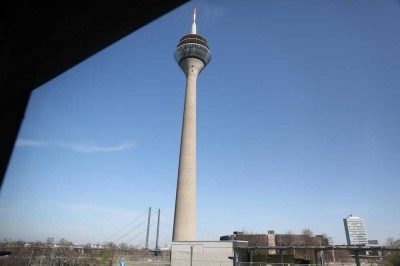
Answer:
top-left (343, 215), bottom-right (368, 245)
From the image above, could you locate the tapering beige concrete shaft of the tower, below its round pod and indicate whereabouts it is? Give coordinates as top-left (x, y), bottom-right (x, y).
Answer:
top-left (172, 58), bottom-right (204, 241)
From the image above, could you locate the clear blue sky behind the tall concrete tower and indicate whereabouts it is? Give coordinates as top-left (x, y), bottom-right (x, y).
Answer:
top-left (0, 0), bottom-right (400, 244)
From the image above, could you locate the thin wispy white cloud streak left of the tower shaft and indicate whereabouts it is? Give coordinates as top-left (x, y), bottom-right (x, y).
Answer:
top-left (16, 139), bottom-right (136, 153)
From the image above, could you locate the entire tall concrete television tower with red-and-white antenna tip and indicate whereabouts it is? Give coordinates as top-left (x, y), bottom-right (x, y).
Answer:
top-left (172, 8), bottom-right (211, 241)
